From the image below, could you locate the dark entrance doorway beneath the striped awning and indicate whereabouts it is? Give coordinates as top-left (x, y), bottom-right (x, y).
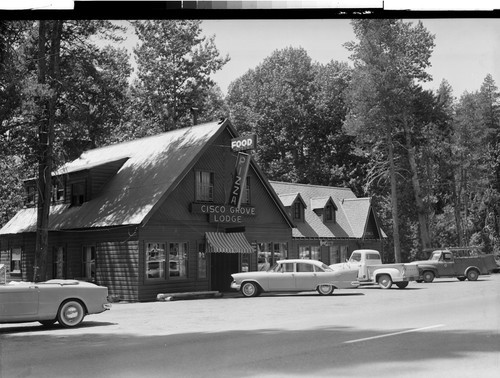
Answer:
top-left (209, 252), bottom-right (240, 292)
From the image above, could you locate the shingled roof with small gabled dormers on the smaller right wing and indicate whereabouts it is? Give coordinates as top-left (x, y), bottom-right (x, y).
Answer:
top-left (270, 181), bottom-right (385, 239)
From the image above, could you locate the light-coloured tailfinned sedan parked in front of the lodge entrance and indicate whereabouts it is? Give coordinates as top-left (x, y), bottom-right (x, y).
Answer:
top-left (231, 259), bottom-right (359, 297)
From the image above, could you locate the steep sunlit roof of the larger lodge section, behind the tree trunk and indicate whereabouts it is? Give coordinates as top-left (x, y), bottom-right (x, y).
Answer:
top-left (0, 121), bottom-right (229, 234)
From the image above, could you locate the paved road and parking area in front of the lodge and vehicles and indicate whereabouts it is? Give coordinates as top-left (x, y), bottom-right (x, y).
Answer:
top-left (0, 274), bottom-right (500, 378)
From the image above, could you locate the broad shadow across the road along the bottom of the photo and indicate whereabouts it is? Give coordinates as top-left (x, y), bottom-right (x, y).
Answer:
top-left (0, 320), bottom-right (500, 377)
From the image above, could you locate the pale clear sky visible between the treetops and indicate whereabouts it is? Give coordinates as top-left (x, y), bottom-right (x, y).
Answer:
top-left (197, 18), bottom-right (500, 98)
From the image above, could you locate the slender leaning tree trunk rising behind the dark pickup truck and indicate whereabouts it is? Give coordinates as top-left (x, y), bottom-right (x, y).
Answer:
top-left (403, 117), bottom-right (431, 250)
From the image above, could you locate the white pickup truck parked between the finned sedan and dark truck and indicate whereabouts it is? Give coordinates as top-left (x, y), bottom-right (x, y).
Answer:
top-left (330, 249), bottom-right (419, 289)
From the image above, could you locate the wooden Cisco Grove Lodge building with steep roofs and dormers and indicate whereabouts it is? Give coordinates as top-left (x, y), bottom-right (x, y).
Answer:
top-left (0, 120), bottom-right (385, 302)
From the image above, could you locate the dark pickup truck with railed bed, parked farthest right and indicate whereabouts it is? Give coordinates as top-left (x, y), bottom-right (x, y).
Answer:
top-left (411, 248), bottom-right (498, 282)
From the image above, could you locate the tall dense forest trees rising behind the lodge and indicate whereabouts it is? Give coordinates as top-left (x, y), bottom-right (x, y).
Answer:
top-left (0, 18), bottom-right (500, 261)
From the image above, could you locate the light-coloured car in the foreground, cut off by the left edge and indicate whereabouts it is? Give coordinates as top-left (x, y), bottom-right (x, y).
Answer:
top-left (0, 280), bottom-right (111, 327)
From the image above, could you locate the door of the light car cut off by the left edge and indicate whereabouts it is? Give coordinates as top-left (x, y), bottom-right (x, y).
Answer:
top-left (0, 284), bottom-right (39, 320)
